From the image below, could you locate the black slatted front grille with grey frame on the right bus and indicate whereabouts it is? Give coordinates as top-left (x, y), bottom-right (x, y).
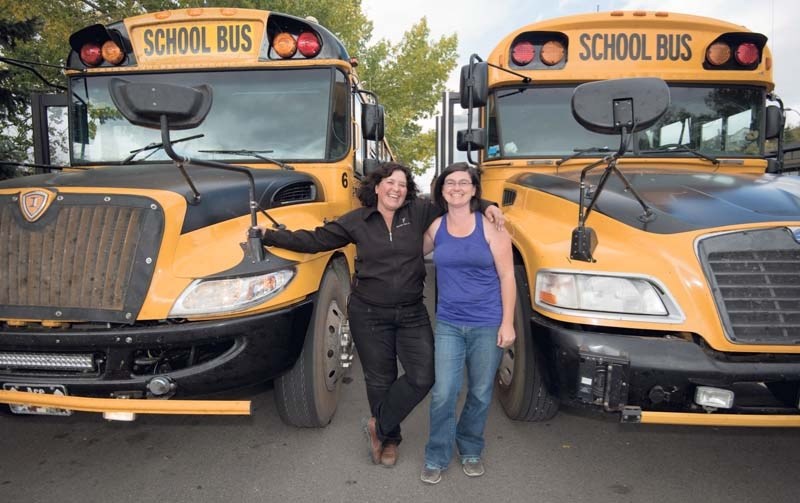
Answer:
top-left (699, 229), bottom-right (800, 345)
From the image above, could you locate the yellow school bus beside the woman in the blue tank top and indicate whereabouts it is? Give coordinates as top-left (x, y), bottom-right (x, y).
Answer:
top-left (440, 11), bottom-right (800, 426)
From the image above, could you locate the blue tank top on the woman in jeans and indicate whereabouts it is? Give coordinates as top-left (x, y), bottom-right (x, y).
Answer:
top-left (433, 212), bottom-right (503, 327)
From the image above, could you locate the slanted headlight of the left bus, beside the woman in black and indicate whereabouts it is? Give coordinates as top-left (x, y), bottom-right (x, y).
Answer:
top-left (169, 269), bottom-right (294, 318)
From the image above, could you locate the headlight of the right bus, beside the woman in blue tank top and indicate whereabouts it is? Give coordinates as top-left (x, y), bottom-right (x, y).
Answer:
top-left (535, 270), bottom-right (684, 323)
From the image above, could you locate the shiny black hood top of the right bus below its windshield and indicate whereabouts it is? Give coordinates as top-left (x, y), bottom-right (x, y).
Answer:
top-left (511, 168), bottom-right (800, 234)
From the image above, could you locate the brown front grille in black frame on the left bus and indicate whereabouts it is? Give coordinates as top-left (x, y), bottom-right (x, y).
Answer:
top-left (0, 194), bottom-right (164, 323)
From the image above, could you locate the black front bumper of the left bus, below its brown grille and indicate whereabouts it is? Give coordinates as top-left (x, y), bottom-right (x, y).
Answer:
top-left (0, 299), bottom-right (313, 397)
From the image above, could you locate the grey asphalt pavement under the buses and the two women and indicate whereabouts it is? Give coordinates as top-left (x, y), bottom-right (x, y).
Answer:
top-left (0, 354), bottom-right (800, 503)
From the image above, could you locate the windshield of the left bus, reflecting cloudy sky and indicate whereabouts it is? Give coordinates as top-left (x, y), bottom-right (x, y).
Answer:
top-left (70, 68), bottom-right (348, 165)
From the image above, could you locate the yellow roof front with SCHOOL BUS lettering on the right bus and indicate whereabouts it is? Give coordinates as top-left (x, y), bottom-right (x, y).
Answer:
top-left (487, 11), bottom-right (774, 90)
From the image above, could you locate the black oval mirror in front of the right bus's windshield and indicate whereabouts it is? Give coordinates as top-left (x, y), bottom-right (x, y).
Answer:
top-left (572, 78), bottom-right (669, 134)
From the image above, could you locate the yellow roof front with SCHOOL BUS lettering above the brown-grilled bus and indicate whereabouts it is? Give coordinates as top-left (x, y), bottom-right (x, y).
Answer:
top-left (67, 8), bottom-right (350, 71)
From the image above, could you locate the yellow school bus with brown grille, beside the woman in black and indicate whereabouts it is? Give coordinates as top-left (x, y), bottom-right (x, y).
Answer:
top-left (0, 8), bottom-right (391, 427)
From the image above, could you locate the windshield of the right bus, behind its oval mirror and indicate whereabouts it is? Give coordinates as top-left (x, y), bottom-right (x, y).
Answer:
top-left (487, 85), bottom-right (764, 159)
